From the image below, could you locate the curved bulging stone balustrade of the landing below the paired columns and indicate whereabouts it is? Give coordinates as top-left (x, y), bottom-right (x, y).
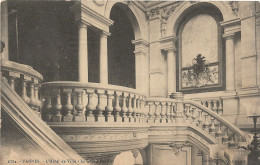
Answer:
top-left (41, 81), bottom-right (147, 123)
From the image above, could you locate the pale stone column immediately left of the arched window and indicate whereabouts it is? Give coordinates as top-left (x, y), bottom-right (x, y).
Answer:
top-left (167, 49), bottom-right (176, 96)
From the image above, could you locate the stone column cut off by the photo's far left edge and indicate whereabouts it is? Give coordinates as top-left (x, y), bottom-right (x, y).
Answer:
top-left (1, 0), bottom-right (9, 60)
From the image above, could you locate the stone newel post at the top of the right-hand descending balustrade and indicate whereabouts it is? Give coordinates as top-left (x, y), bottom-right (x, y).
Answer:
top-left (170, 92), bottom-right (185, 123)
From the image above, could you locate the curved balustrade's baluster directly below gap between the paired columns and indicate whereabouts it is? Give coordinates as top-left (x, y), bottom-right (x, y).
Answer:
top-left (86, 89), bottom-right (96, 122)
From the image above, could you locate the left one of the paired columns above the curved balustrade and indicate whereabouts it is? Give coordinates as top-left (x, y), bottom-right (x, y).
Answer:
top-left (78, 22), bottom-right (88, 82)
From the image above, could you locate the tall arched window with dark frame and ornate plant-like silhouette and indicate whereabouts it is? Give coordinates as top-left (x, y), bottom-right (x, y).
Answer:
top-left (178, 12), bottom-right (223, 93)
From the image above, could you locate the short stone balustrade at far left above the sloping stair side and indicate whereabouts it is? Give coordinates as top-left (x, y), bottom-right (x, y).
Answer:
top-left (1, 60), bottom-right (43, 115)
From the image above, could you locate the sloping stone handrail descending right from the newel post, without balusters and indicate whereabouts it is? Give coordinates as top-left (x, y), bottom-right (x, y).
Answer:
top-left (184, 100), bottom-right (247, 140)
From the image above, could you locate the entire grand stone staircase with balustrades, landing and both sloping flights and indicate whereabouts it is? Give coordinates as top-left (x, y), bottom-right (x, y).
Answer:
top-left (1, 61), bottom-right (252, 164)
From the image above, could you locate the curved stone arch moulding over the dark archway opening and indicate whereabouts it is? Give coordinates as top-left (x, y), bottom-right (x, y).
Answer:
top-left (104, 1), bottom-right (144, 40)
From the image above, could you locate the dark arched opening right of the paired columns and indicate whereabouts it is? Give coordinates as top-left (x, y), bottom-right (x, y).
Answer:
top-left (108, 4), bottom-right (136, 88)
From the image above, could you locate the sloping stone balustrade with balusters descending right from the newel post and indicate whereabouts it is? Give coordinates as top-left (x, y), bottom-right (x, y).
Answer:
top-left (184, 100), bottom-right (245, 145)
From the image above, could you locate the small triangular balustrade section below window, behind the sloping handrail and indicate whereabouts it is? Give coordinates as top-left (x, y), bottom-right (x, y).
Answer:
top-left (192, 97), bottom-right (223, 115)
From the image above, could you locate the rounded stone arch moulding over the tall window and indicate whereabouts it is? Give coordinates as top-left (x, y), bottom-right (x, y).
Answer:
top-left (166, 1), bottom-right (234, 36)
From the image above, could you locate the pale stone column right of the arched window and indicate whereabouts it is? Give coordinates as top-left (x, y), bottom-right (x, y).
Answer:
top-left (223, 33), bottom-right (235, 92)
